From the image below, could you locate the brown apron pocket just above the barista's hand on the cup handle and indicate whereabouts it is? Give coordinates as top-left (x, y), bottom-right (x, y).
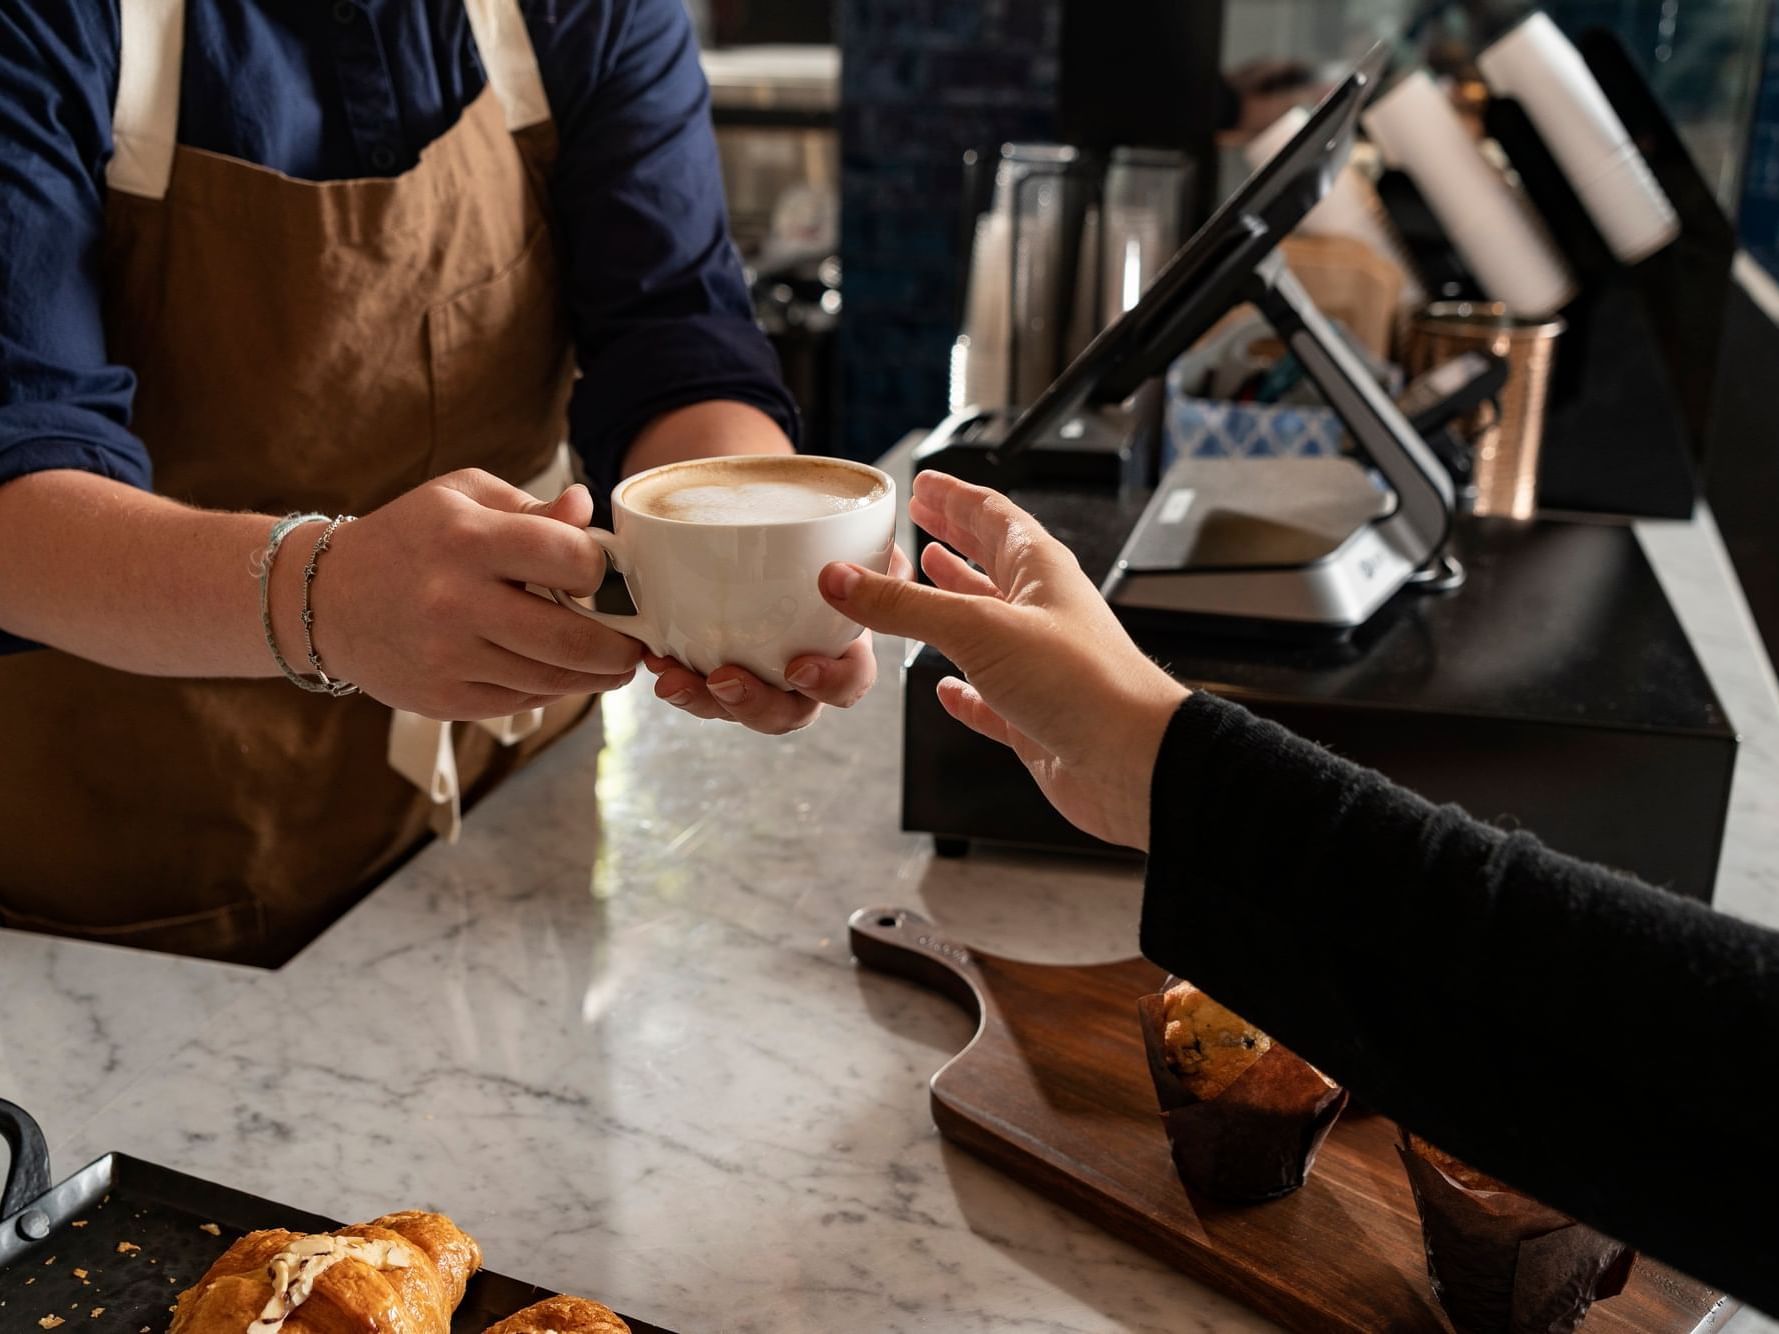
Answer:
top-left (425, 224), bottom-right (573, 482)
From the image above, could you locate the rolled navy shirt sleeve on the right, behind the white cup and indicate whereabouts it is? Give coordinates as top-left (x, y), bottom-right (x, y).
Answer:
top-left (527, 0), bottom-right (799, 489)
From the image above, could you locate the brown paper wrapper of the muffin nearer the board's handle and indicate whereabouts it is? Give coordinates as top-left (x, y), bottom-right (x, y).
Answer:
top-left (1137, 978), bottom-right (1347, 1202)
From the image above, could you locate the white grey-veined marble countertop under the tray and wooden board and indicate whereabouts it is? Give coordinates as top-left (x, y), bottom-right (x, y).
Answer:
top-left (0, 490), bottom-right (1779, 1334)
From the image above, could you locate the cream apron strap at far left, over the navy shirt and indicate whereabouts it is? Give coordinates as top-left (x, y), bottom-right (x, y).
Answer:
top-left (105, 0), bottom-right (185, 199)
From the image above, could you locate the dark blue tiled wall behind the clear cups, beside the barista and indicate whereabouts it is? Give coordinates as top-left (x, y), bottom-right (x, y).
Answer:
top-left (840, 0), bottom-right (1062, 459)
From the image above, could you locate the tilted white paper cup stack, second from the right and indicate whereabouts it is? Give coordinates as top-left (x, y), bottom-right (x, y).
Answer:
top-left (1364, 69), bottom-right (1574, 318)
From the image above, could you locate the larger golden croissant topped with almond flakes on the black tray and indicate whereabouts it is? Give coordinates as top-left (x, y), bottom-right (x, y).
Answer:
top-left (167, 1211), bottom-right (483, 1334)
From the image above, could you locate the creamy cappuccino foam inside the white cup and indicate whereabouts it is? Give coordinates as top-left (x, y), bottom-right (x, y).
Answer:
top-left (624, 457), bottom-right (884, 525)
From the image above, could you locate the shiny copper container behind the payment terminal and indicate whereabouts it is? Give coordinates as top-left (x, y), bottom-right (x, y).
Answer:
top-left (1409, 301), bottom-right (1564, 519)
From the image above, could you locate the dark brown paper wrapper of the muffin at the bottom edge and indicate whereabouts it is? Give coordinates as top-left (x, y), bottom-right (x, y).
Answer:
top-left (1397, 1142), bottom-right (1637, 1334)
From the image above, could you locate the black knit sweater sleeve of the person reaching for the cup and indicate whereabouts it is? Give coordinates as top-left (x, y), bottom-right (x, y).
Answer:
top-left (1142, 694), bottom-right (1779, 1313)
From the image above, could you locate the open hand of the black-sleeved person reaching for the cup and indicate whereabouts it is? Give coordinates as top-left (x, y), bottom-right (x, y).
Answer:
top-left (822, 473), bottom-right (1187, 848)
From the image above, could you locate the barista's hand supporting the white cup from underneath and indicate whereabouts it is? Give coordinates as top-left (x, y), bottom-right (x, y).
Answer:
top-left (642, 548), bottom-right (914, 736)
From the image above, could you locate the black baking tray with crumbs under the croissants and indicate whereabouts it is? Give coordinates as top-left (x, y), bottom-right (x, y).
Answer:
top-left (0, 1099), bottom-right (671, 1334)
